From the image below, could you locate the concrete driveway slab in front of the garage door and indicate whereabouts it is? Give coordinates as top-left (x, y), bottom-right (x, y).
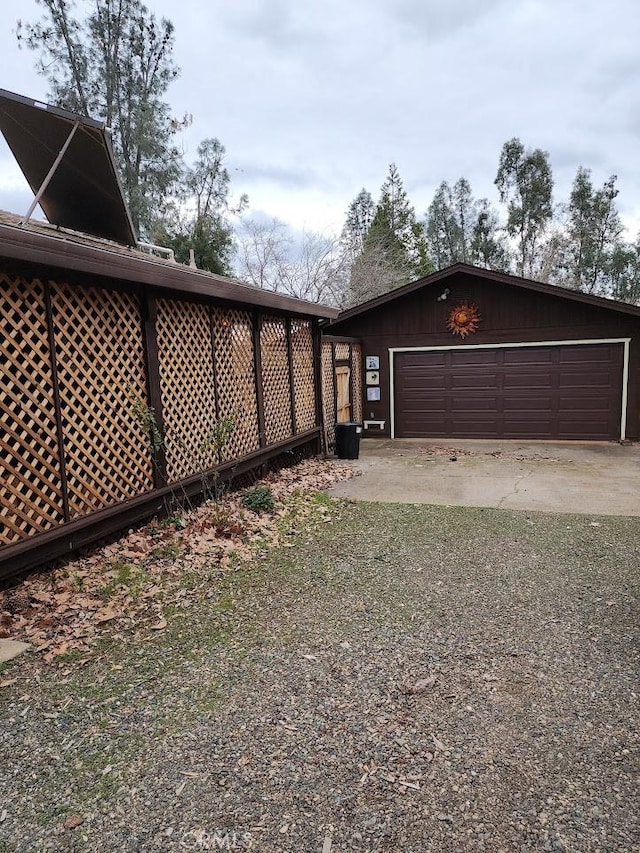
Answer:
top-left (330, 439), bottom-right (640, 516)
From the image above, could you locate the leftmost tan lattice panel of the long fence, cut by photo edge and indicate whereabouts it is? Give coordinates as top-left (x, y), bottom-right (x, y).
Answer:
top-left (0, 275), bottom-right (64, 544)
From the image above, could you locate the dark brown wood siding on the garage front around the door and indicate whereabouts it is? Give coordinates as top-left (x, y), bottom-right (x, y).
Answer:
top-left (331, 272), bottom-right (640, 440)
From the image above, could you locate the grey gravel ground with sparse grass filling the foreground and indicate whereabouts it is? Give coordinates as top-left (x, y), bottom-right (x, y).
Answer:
top-left (0, 503), bottom-right (640, 853)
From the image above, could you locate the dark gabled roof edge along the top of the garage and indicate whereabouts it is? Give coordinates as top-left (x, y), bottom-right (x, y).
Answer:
top-left (332, 263), bottom-right (640, 325)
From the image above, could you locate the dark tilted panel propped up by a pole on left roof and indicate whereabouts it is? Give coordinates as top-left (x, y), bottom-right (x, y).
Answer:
top-left (0, 89), bottom-right (137, 246)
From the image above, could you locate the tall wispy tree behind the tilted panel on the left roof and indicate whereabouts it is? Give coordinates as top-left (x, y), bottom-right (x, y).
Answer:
top-left (17, 0), bottom-right (181, 236)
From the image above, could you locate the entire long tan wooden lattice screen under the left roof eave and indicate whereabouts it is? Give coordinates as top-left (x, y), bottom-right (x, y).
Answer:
top-left (0, 274), bottom-right (319, 568)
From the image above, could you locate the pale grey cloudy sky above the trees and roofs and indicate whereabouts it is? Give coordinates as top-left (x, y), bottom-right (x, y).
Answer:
top-left (0, 0), bottom-right (640, 237)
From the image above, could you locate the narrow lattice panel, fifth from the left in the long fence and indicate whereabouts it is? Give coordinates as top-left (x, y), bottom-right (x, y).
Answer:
top-left (260, 316), bottom-right (291, 444)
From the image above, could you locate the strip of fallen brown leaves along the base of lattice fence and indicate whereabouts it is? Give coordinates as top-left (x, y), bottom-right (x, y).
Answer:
top-left (0, 459), bottom-right (355, 664)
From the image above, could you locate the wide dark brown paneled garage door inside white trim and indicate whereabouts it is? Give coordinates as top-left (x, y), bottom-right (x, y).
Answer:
top-left (394, 344), bottom-right (623, 440)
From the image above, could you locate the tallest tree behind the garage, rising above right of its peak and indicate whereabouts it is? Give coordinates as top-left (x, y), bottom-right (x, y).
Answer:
top-left (495, 137), bottom-right (553, 276)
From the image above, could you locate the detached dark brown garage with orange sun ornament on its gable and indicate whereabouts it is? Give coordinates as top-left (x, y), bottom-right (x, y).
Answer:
top-left (326, 263), bottom-right (640, 441)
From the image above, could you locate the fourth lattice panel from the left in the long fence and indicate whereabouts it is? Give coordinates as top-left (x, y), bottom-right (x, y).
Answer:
top-left (212, 308), bottom-right (260, 461)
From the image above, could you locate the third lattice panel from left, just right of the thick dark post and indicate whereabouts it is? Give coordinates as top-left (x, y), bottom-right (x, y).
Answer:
top-left (156, 299), bottom-right (218, 483)
